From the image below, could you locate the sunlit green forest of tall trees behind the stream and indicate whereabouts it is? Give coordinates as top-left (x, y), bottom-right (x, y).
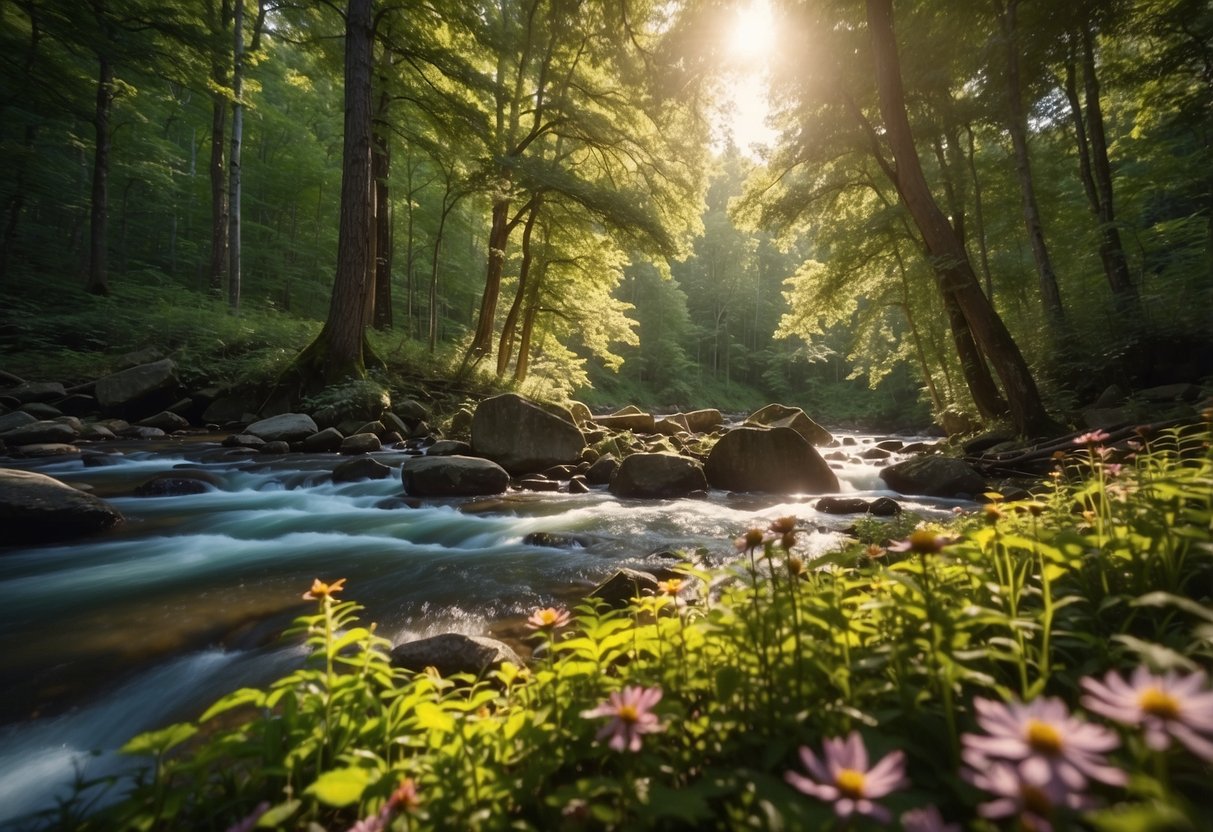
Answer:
top-left (0, 0), bottom-right (1213, 431)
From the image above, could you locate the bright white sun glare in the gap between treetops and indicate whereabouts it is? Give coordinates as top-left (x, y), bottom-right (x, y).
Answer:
top-left (721, 0), bottom-right (775, 153)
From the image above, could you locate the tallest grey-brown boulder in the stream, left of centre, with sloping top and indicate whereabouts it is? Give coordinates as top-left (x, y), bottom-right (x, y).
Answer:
top-left (472, 393), bottom-right (586, 474)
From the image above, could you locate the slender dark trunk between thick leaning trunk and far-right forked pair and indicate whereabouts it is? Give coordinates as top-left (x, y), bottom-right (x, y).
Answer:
top-left (996, 0), bottom-right (1066, 332)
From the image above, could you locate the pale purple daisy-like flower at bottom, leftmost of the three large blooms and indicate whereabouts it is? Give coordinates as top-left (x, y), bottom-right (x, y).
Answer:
top-left (784, 731), bottom-right (909, 824)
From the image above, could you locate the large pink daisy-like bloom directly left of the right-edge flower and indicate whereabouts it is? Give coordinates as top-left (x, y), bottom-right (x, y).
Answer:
top-left (961, 697), bottom-right (1127, 790)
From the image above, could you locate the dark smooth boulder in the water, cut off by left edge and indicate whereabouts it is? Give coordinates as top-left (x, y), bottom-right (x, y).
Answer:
top-left (0, 468), bottom-right (123, 543)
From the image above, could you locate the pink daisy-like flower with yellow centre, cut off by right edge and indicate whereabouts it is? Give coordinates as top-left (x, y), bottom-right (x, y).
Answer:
top-left (1082, 667), bottom-right (1213, 762)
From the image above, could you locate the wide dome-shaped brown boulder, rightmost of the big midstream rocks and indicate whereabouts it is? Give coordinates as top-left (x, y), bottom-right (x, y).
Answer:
top-left (704, 427), bottom-right (838, 494)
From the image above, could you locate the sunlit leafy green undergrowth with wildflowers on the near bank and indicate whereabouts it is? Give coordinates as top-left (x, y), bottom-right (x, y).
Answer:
top-left (46, 424), bottom-right (1213, 831)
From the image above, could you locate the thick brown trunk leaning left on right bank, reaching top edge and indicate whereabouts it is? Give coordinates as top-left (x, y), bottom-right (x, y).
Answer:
top-left (866, 0), bottom-right (1055, 435)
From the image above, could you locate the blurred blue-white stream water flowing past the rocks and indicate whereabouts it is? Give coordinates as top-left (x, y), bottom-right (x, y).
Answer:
top-left (0, 437), bottom-right (965, 825)
